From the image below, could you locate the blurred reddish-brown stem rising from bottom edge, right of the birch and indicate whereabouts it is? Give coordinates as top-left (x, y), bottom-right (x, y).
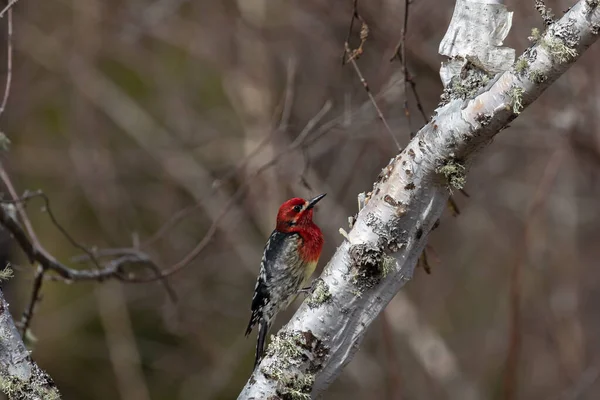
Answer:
top-left (504, 146), bottom-right (565, 400)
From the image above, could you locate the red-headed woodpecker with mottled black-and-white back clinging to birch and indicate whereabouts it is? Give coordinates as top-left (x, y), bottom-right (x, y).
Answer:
top-left (246, 193), bottom-right (325, 369)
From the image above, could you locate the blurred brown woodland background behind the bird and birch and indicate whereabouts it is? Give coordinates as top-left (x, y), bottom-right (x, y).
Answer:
top-left (0, 0), bottom-right (600, 400)
